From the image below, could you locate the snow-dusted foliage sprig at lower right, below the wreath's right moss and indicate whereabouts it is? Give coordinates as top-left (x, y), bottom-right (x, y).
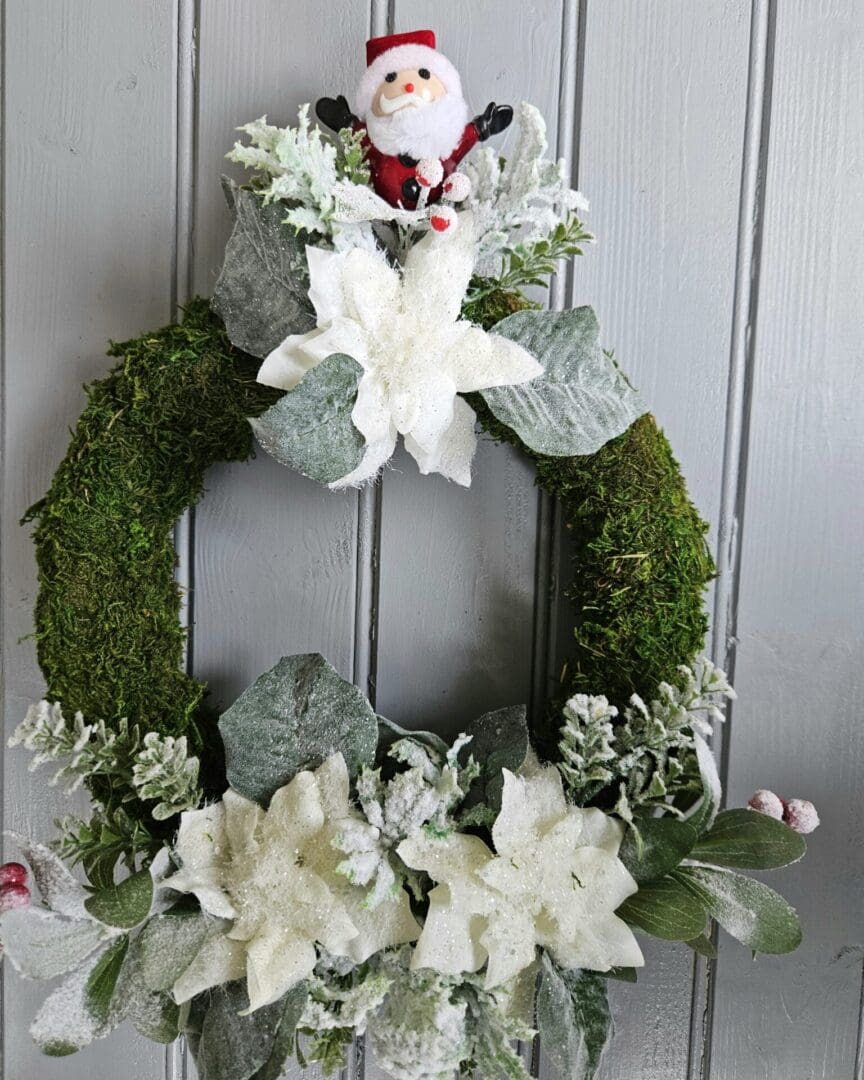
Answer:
top-left (558, 657), bottom-right (734, 821)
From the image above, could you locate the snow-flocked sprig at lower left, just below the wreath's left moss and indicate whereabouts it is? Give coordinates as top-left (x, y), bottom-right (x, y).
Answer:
top-left (9, 700), bottom-right (201, 821)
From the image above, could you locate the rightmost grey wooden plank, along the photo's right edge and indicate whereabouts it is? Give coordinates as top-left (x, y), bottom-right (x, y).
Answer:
top-left (711, 0), bottom-right (864, 1080)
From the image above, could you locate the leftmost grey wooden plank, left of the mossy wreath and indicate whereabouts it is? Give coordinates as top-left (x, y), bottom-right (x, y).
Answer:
top-left (2, 0), bottom-right (176, 1080)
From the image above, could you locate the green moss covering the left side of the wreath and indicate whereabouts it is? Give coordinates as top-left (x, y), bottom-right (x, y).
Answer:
top-left (25, 300), bottom-right (279, 743)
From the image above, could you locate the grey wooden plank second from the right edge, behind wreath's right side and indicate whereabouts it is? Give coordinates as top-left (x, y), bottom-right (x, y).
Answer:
top-left (574, 0), bottom-right (750, 1080)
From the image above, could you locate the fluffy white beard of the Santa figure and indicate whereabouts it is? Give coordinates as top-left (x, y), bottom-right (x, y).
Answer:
top-left (365, 93), bottom-right (468, 159)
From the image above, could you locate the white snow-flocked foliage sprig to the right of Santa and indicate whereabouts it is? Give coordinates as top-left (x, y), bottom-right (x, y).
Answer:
top-left (463, 102), bottom-right (592, 285)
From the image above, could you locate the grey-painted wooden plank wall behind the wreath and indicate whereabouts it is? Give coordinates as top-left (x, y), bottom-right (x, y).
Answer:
top-left (2, 0), bottom-right (864, 1080)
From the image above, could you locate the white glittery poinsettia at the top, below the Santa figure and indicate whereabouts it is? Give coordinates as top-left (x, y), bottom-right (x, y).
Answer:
top-left (258, 215), bottom-right (542, 488)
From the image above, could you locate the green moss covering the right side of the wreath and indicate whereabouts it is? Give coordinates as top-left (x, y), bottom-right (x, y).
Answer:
top-left (472, 399), bottom-right (715, 746)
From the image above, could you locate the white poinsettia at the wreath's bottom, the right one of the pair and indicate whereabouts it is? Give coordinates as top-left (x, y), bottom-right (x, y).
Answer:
top-left (399, 767), bottom-right (644, 989)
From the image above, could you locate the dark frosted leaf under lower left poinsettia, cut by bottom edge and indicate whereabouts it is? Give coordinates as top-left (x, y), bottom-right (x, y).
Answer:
top-left (197, 981), bottom-right (307, 1080)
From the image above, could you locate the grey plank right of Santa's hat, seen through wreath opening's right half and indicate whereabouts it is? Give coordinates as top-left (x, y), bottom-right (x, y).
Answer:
top-left (377, 0), bottom-right (562, 734)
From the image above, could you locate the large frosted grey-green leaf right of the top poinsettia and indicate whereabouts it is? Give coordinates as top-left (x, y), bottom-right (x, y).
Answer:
top-left (481, 307), bottom-right (647, 457)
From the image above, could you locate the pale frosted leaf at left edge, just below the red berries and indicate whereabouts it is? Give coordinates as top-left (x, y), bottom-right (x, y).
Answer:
top-left (0, 907), bottom-right (106, 978)
